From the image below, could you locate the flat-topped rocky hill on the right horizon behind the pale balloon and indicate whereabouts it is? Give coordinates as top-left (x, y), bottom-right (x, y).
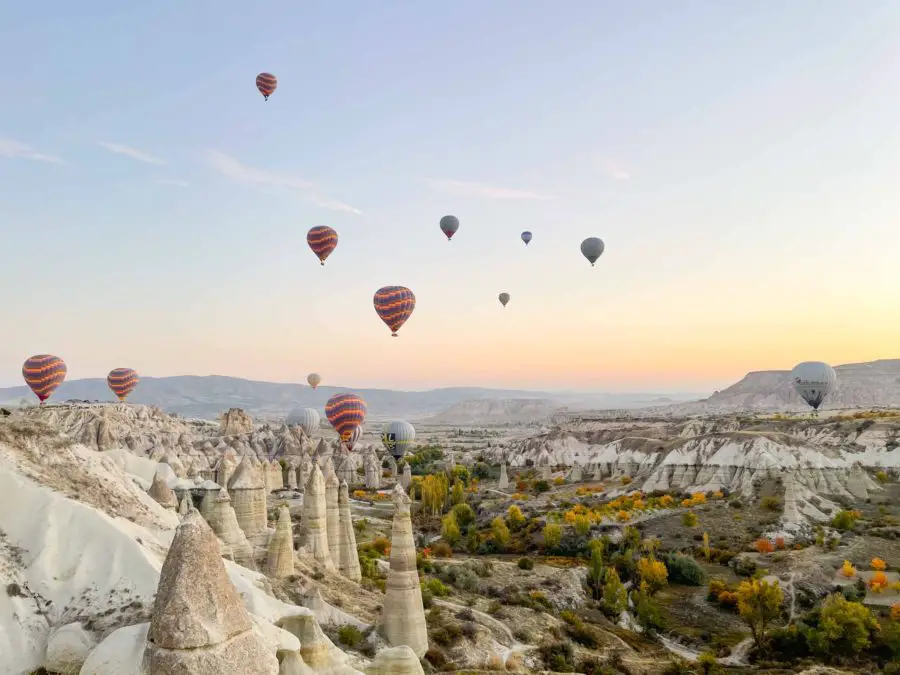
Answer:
top-left (643, 359), bottom-right (900, 415)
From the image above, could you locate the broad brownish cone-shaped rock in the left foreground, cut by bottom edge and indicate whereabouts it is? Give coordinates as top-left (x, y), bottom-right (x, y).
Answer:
top-left (144, 509), bottom-right (278, 675)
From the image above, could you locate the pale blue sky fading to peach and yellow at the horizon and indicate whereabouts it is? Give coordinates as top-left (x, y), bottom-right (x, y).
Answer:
top-left (0, 0), bottom-right (900, 392)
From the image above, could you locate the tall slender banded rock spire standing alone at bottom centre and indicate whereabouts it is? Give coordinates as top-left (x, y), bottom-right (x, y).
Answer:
top-left (379, 485), bottom-right (428, 658)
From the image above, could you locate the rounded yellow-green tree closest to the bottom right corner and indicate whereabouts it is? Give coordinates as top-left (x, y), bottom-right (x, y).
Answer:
top-left (809, 594), bottom-right (879, 659)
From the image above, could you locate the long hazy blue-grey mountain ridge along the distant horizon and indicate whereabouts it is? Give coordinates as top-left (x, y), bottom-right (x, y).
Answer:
top-left (0, 375), bottom-right (693, 420)
